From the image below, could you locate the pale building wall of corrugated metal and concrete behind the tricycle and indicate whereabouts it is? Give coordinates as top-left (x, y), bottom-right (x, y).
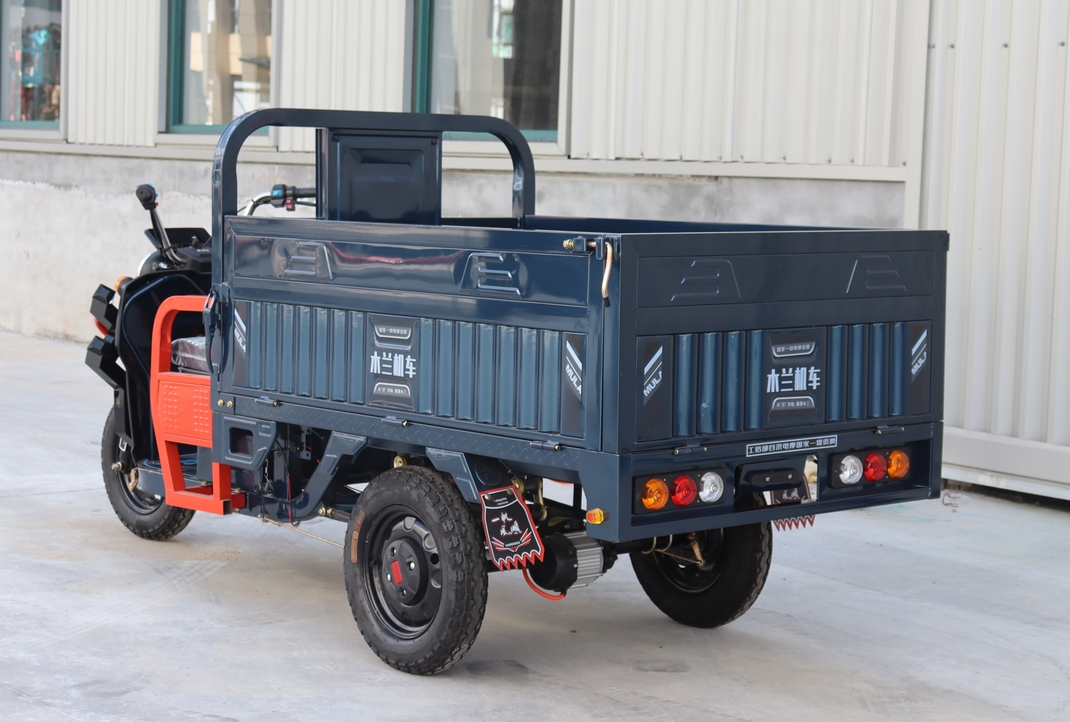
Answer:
top-left (0, 0), bottom-right (1070, 497)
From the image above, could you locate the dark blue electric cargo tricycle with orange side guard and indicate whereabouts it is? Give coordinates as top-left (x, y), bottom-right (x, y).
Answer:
top-left (87, 109), bottom-right (948, 674)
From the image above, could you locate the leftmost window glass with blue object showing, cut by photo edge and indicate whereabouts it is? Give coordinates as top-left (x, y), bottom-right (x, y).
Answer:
top-left (0, 0), bottom-right (63, 122)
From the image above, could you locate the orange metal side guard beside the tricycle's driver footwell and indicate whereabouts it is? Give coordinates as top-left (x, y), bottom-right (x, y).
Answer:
top-left (149, 296), bottom-right (245, 513)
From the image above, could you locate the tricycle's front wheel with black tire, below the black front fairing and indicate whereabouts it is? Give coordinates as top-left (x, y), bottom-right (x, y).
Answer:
top-left (101, 409), bottom-right (194, 541)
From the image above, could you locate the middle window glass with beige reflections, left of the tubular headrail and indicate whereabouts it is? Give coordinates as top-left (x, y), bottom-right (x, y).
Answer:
top-left (171, 0), bottom-right (272, 129)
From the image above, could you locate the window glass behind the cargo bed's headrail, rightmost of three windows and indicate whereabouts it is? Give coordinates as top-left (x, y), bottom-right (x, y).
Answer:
top-left (417, 0), bottom-right (562, 139)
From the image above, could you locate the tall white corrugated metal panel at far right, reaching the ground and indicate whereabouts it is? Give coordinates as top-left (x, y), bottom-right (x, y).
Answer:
top-left (922, 0), bottom-right (1070, 497)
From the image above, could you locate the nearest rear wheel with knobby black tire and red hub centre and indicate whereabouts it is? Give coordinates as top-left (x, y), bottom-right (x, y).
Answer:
top-left (342, 466), bottom-right (487, 674)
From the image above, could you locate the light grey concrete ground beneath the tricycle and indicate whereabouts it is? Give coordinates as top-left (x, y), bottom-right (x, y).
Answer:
top-left (6, 334), bottom-right (1070, 722)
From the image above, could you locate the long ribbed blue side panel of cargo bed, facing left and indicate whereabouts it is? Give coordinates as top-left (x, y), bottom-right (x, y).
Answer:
top-left (234, 301), bottom-right (586, 437)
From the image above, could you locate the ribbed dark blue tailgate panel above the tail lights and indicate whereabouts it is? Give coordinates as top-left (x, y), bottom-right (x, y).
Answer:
top-left (637, 321), bottom-right (932, 443)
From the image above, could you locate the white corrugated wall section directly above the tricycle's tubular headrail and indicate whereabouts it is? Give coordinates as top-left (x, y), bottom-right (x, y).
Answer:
top-left (277, 0), bottom-right (406, 151)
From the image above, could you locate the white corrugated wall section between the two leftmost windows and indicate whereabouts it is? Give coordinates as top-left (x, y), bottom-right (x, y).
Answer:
top-left (63, 0), bottom-right (162, 145)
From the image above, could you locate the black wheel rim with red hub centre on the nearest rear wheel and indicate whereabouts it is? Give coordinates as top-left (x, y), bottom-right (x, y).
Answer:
top-left (361, 508), bottom-right (442, 640)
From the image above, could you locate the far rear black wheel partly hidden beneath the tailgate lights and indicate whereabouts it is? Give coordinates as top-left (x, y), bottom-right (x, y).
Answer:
top-left (631, 502), bottom-right (773, 629)
